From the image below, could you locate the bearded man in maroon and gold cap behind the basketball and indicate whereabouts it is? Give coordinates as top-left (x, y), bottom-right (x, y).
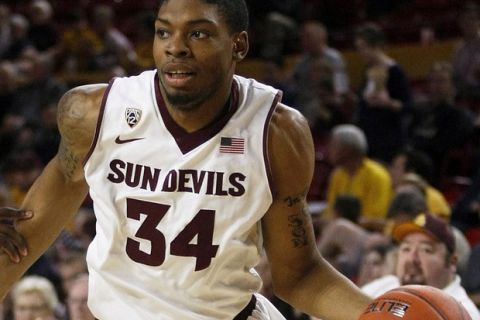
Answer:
top-left (362, 214), bottom-right (480, 319)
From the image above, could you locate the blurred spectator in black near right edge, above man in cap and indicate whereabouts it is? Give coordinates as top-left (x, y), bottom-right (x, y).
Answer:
top-left (408, 62), bottom-right (473, 183)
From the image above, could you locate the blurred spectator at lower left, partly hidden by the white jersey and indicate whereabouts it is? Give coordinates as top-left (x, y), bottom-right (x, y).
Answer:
top-left (67, 273), bottom-right (95, 320)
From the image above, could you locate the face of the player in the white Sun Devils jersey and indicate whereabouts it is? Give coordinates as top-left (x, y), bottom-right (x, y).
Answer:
top-left (153, 0), bottom-right (246, 110)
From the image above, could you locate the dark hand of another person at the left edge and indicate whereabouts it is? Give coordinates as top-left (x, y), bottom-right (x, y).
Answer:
top-left (0, 208), bottom-right (33, 263)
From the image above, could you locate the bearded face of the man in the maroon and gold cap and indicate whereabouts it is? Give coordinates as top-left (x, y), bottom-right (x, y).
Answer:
top-left (397, 233), bottom-right (455, 289)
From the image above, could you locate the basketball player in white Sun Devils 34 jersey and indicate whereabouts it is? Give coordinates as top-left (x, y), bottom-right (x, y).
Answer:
top-left (0, 0), bottom-right (370, 320)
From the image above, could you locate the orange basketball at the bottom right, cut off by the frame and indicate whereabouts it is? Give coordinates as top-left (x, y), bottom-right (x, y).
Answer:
top-left (358, 285), bottom-right (472, 320)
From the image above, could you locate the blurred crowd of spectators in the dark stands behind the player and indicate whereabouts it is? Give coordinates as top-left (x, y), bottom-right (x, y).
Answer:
top-left (0, 0), bottom-right (480, 320)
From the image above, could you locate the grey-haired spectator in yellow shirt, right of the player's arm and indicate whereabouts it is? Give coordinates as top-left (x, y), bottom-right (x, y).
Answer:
top-left (327, 124), bottom-right (392, 224)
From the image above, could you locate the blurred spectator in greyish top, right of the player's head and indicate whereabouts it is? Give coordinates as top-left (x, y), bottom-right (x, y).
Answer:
top-left (292, 20), bottom-right (349, 132)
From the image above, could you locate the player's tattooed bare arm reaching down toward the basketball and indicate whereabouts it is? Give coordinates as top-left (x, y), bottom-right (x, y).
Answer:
top-left (262, 104), bottom-right (370, 320)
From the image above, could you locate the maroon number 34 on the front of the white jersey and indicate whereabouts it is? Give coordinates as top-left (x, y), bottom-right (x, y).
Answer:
top-left (126, 198), bottom-right (218, 271)
